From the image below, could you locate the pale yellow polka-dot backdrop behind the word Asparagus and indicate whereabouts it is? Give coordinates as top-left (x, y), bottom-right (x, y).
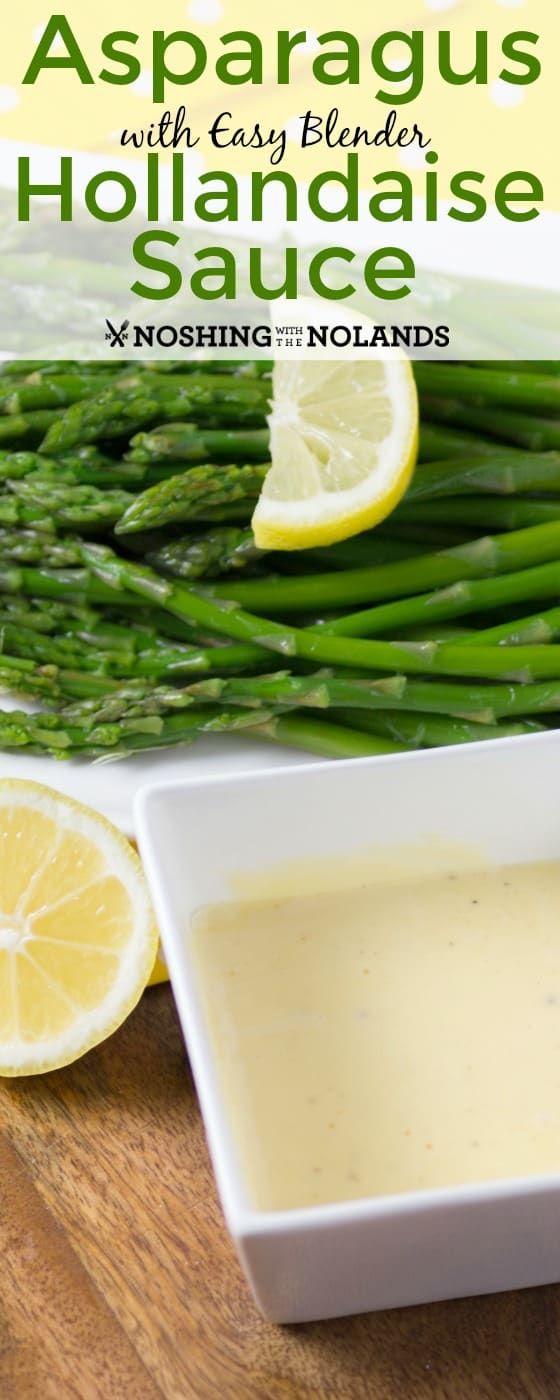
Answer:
top-left (0, 0), bottom-right (560, 210)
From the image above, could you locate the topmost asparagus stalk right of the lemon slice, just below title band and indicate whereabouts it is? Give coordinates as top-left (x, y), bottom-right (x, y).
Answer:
top-left (414, 360), bottom-right (560, 413)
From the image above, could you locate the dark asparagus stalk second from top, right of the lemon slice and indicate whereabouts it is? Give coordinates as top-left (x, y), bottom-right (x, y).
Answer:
top-left (421, 393), bottom-right (560, 452)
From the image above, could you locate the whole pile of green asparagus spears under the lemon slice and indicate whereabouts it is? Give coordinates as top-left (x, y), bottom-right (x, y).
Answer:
top-left (0, 351), bottom-right (560, 757)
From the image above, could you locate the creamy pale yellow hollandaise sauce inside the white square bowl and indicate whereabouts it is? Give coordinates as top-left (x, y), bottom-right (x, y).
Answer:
top-left (192, 862), bottom-right (560, 1210)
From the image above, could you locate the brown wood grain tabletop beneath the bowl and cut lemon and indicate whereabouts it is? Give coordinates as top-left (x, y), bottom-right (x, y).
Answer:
top-left (0, 987), bottom-right (560, 1400)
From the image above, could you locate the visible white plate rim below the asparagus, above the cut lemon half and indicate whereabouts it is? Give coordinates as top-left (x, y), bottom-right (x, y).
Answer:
top-left (0, 733), bottom-right (318, 836)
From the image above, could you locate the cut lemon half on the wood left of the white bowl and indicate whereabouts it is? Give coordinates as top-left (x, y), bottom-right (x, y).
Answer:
top-left (0, 780), bottom-right (158, 1075)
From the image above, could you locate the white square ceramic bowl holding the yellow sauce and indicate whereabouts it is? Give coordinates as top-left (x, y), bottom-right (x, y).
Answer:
top-left (136, 732), bottom-right (560, 1323)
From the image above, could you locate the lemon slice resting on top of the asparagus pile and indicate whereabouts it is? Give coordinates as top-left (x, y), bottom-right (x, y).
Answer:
top-left (252, 354), bottom-right (419, 549)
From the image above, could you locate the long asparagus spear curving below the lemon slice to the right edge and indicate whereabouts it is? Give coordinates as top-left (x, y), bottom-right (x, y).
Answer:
top-left (74, 540), bottom-right (560, 682)
